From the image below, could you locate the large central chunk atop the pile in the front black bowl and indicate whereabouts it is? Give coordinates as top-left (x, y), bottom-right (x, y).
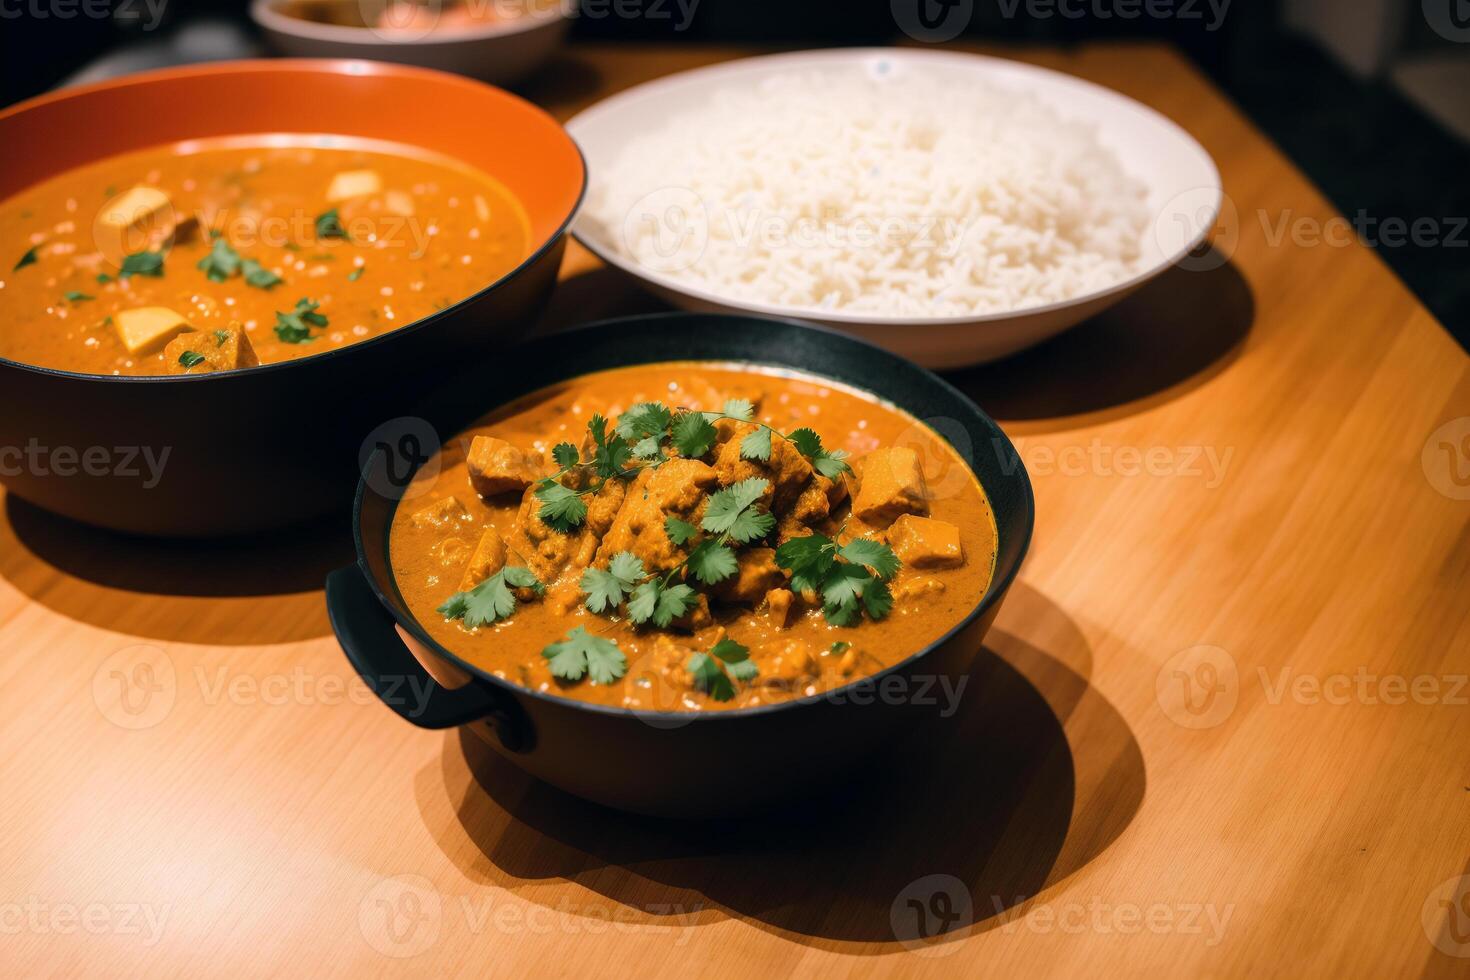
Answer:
top-left (597, 460), bottom-right (716, 572)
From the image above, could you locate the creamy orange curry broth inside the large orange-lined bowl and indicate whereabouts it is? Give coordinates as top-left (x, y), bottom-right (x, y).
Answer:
top-left (0, 135), bottom-right (529, 375)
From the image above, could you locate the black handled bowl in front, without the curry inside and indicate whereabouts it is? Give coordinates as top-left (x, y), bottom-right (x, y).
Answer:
top-left (326, 313), bottom-right (1035, 817)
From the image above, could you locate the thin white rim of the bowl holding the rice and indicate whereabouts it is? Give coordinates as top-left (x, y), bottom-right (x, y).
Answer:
top-left (567, 45), bottom-right (1225, 328)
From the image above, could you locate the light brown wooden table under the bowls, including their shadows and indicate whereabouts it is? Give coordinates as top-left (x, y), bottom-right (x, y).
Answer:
top-left (0, 46), bottom-right (1470, 977)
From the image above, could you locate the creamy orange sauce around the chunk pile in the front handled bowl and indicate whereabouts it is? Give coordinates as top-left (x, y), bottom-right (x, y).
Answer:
top-left (390, 363), bottom-right (997, 710)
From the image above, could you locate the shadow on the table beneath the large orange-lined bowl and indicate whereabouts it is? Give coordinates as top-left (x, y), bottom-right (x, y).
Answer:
top-left (0, 495), bottom-right (356, 645)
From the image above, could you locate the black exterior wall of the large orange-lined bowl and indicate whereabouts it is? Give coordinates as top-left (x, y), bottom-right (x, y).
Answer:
top-left (0, 235), bottom-right (566, 538)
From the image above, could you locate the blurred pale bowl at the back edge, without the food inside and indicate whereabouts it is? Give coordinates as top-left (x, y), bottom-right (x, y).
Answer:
top-left (250, 0), bottom-right (570, 85)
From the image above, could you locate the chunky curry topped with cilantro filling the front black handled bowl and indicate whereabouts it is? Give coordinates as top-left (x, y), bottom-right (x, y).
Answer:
top-left (391, 363), bottom-right (995, 711)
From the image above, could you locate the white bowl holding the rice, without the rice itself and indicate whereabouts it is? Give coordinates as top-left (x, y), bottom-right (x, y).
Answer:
top-left (566, 48), bottom-right (1223, 367)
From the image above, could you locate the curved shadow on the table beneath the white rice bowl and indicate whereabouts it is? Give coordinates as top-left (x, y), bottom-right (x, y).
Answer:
top-left (947, 251), bottom-right (1255, 433)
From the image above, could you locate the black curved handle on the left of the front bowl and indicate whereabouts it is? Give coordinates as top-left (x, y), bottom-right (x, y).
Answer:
top-left (326, 566), bottom-right (531, 752)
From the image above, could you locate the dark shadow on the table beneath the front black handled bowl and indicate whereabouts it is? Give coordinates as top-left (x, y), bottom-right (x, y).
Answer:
top-left (417, 583), bottom-right (1147, 952)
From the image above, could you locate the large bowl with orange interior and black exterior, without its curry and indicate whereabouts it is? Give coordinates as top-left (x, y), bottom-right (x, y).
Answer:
top-left (0, 60), bottom-right (587, 536)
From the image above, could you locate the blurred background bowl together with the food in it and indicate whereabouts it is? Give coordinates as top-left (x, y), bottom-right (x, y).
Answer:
top-left (250, 0), bottom-right (570, 84)
